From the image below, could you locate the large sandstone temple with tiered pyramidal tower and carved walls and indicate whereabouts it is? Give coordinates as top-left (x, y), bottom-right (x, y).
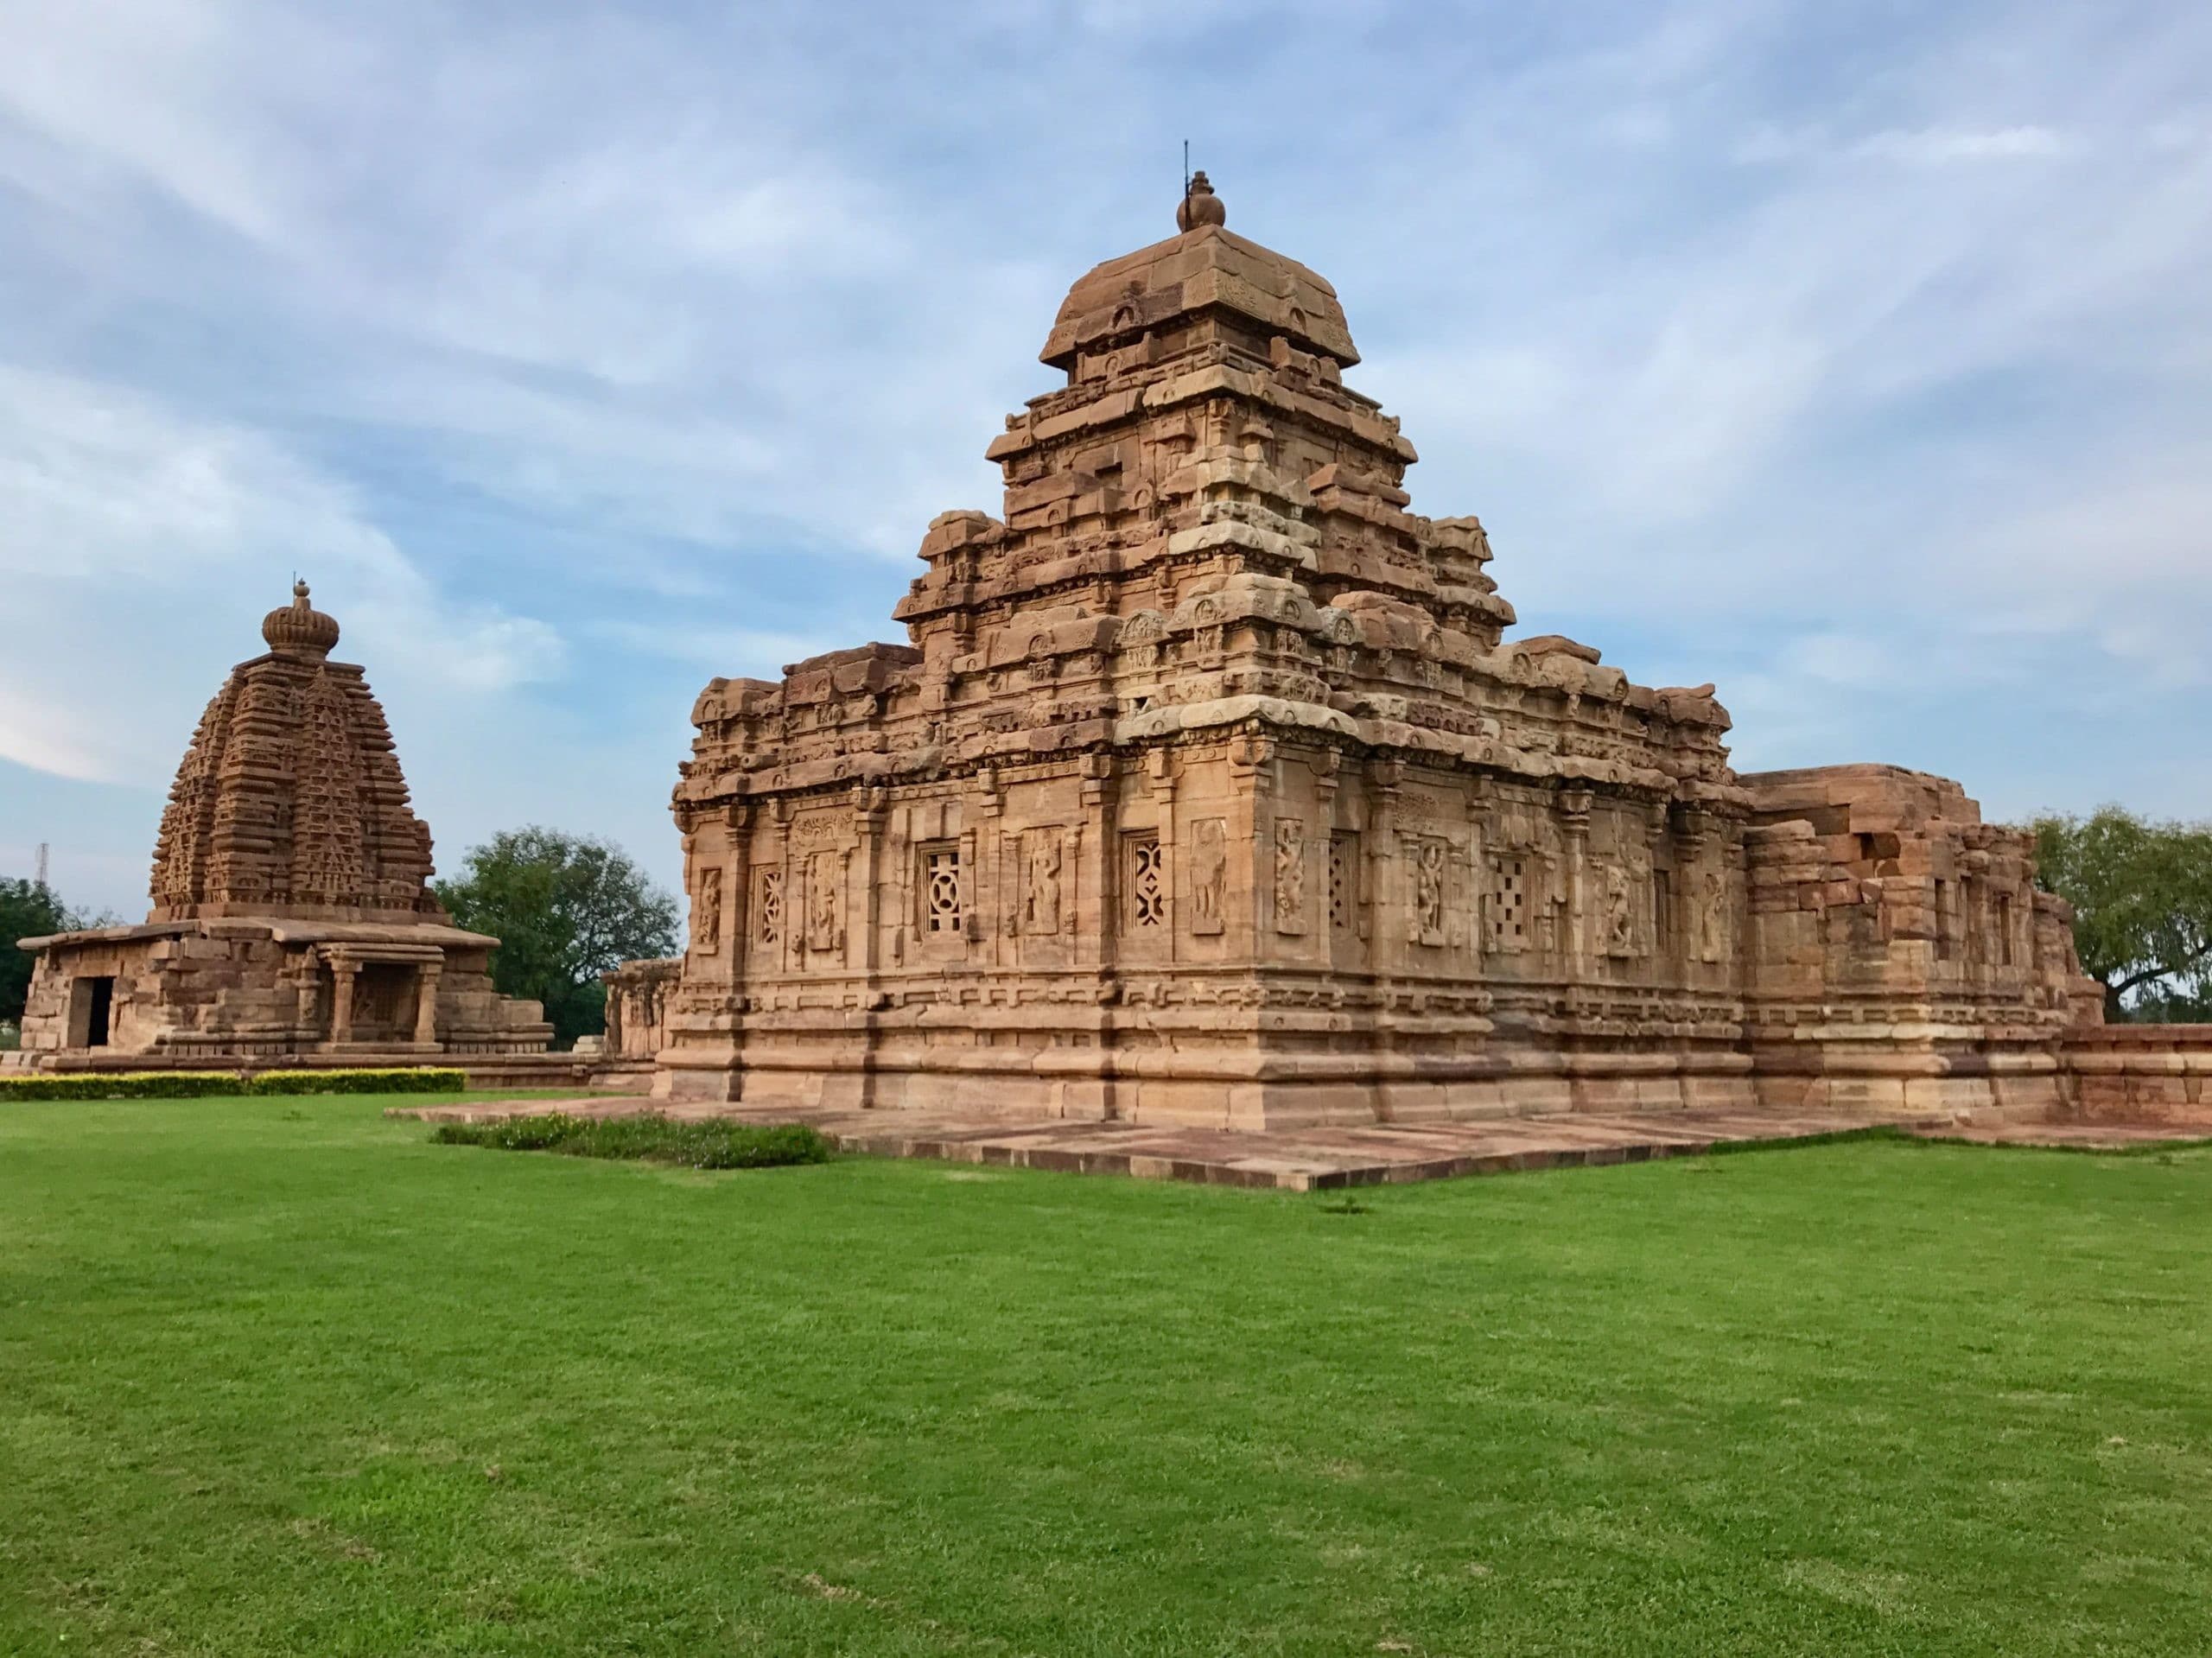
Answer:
top-left (641, 175), bottom-right (2101, 1128)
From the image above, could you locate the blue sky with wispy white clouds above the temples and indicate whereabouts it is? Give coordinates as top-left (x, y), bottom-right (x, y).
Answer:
top-left (0, 0), bottom-right (2212, 918)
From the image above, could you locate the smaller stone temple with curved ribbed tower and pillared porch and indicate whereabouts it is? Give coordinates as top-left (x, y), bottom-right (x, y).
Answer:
top-left (0, 581), bottom-right (553, 1070)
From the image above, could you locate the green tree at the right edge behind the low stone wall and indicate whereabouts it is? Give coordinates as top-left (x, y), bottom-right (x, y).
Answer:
top-left (2033, 807), bottom-right (2212, 1020)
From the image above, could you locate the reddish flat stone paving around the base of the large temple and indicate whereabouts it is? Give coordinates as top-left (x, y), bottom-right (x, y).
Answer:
top-left (387, 1099), bottom-right (1948, 1191)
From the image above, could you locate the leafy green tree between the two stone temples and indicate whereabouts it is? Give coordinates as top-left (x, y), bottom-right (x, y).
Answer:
top-left (435, 824), bottom-right (677, 1045)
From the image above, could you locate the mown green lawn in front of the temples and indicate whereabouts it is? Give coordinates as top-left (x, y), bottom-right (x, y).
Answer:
top-left (0, 1099), bottom-right (2212, 1658)
